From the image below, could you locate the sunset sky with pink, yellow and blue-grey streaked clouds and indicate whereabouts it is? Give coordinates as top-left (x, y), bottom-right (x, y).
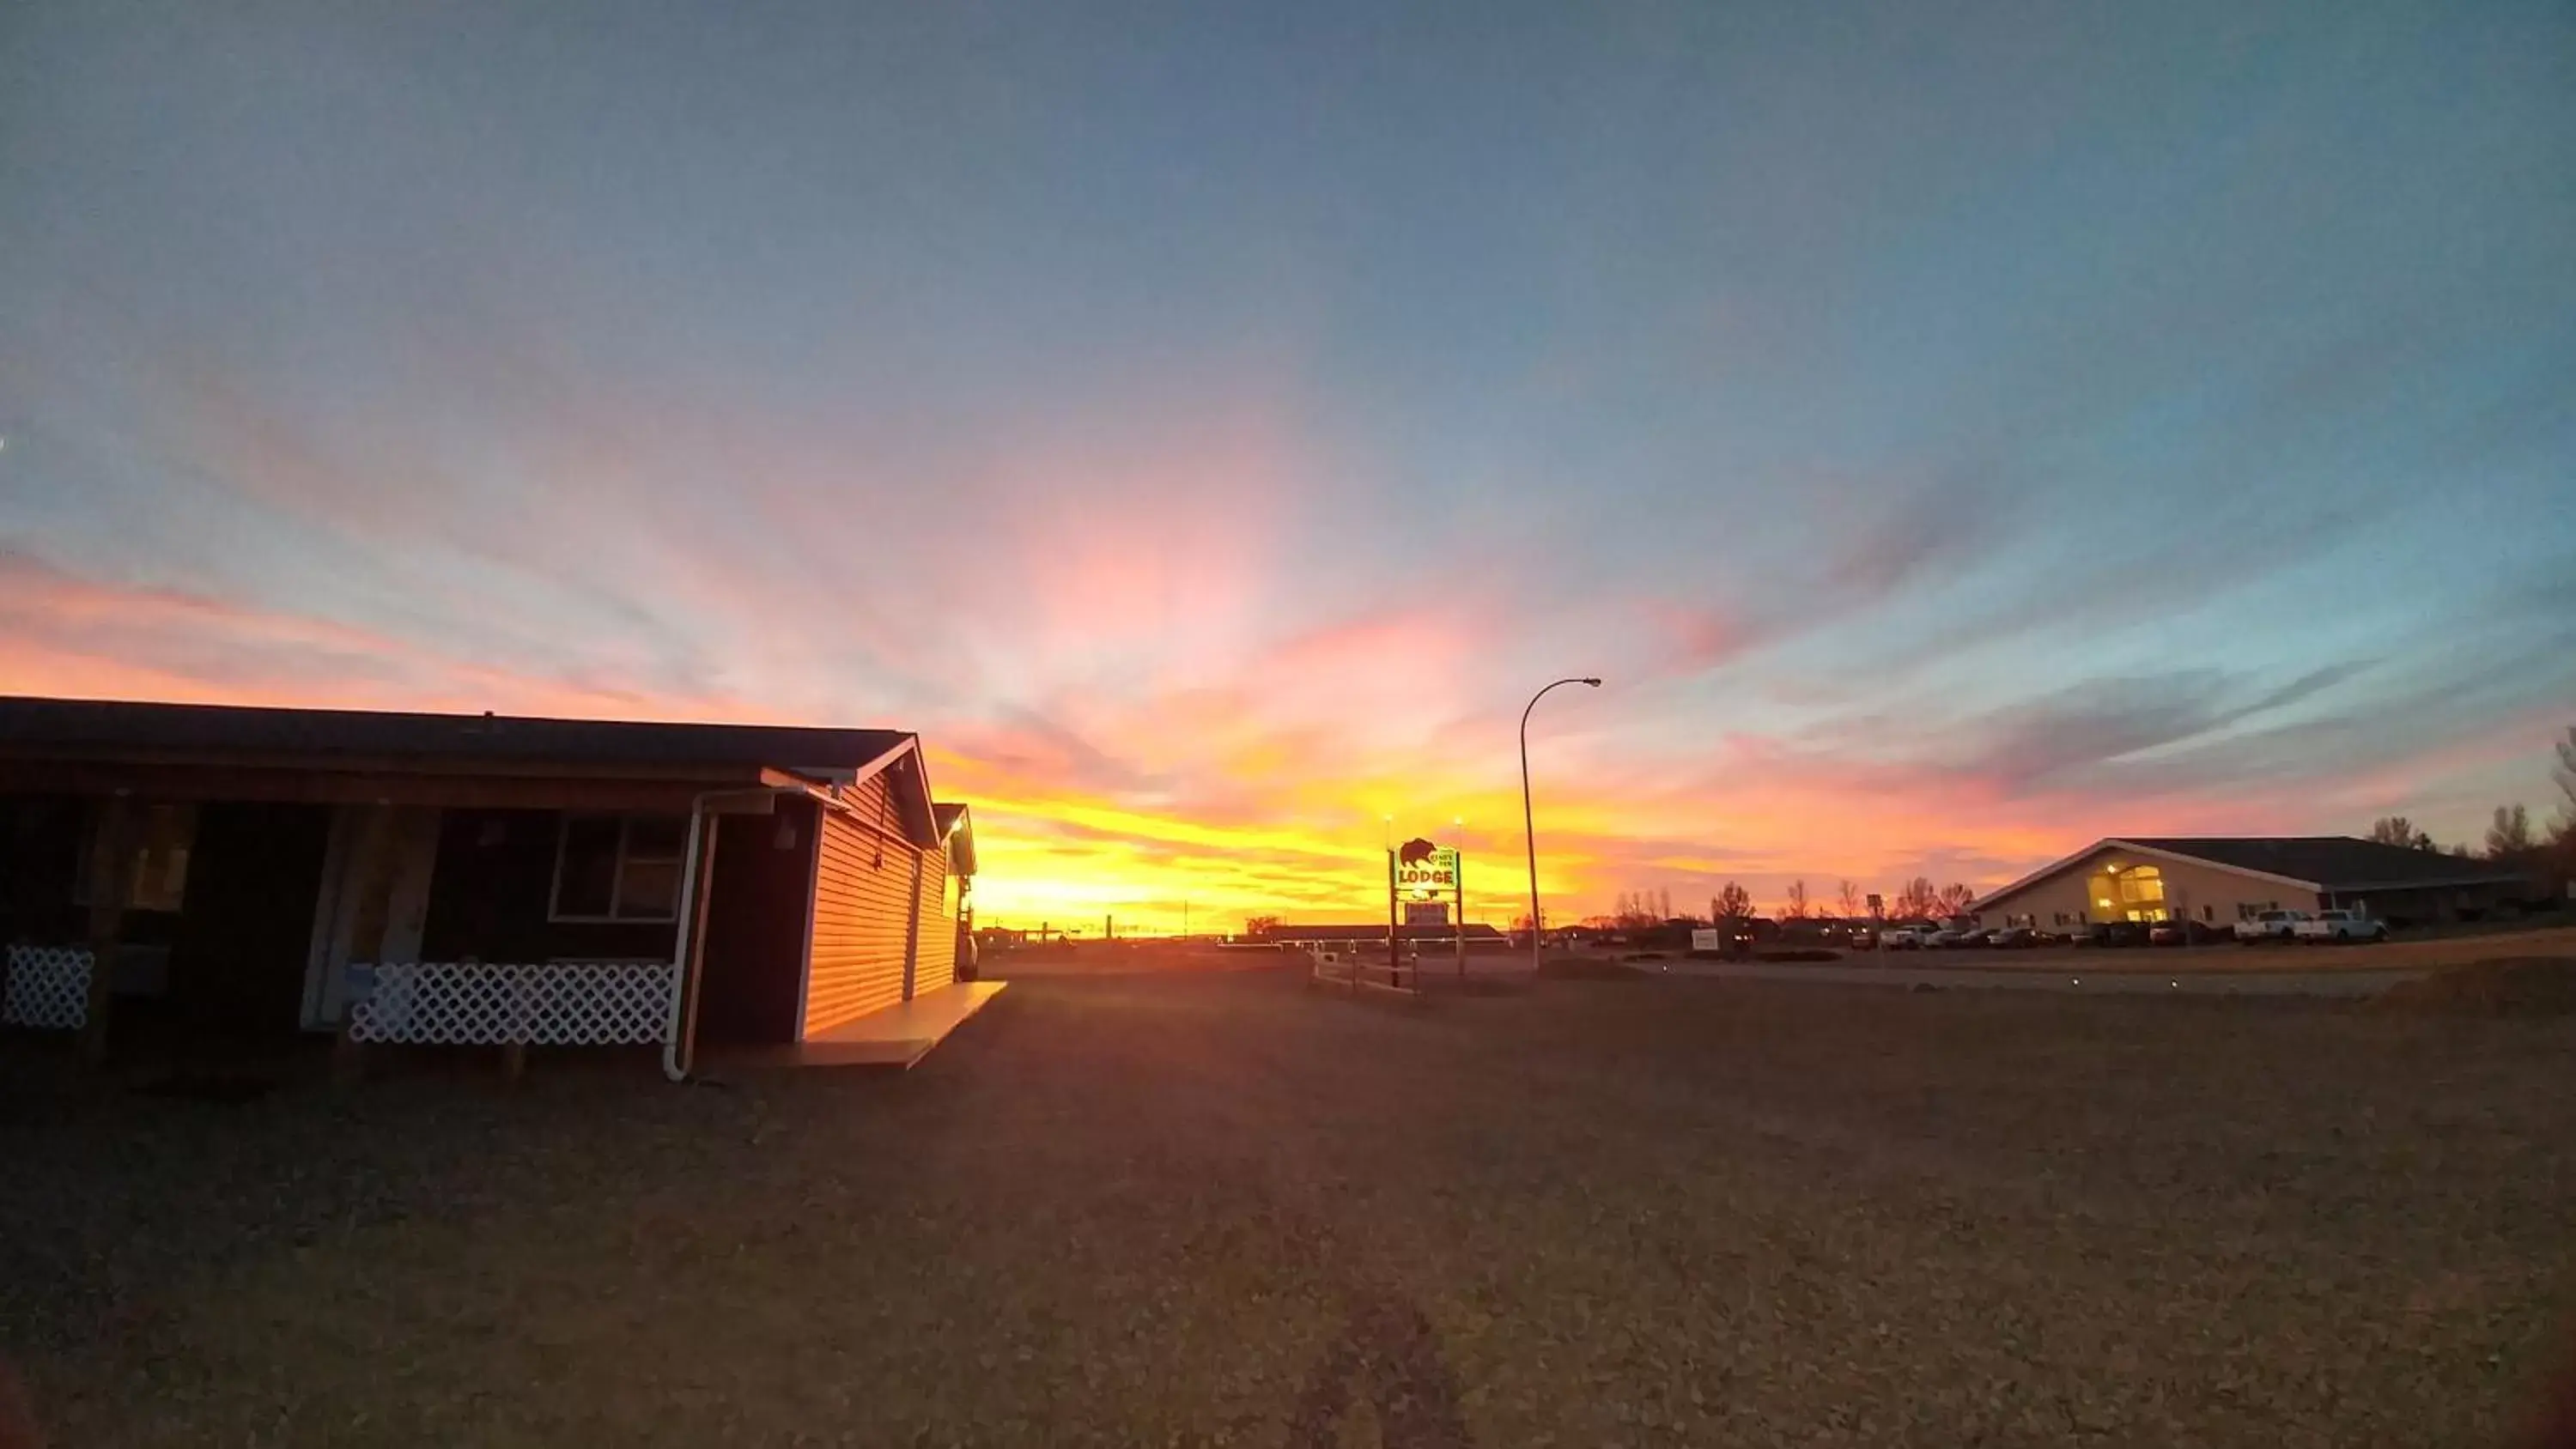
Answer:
top-left (0, 0), bottom-right (2576, 929)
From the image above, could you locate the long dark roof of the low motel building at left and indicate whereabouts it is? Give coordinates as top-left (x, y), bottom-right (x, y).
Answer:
top-left (0, 695), bottom-right (912, 769)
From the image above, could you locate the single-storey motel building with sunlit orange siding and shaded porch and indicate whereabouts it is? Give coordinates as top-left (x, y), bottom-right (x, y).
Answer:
top-left (0, 698), bottom-right (994, 1078)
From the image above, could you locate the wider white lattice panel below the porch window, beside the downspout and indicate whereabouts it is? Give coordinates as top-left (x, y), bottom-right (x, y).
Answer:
top-left (348, 960), bottom-right (672, 1047)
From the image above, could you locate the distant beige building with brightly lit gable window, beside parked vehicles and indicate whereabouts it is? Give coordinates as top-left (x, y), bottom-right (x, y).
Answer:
top-left (1971, 836), bottom-right (2530, 929)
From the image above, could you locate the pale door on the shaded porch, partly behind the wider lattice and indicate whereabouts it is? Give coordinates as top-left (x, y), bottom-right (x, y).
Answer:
top-left (304, 805), bottom-right (440, 1032)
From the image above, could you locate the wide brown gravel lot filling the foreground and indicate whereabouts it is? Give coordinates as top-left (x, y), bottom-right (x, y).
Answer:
top-left (0, 973), bottom-right (2576, 1449)
